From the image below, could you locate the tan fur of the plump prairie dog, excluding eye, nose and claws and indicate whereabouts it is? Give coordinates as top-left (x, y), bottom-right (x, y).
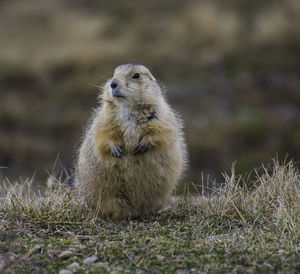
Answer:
top-left (77, 64), bottom-right (186, 220)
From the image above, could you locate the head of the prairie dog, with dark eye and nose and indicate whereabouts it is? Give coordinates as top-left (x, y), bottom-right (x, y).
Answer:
top-left (104, 64), bottom-right (161, 105)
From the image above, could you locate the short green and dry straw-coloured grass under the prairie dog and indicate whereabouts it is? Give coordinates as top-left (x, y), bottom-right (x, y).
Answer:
top-left (0, 160), bottom-right (300, 273)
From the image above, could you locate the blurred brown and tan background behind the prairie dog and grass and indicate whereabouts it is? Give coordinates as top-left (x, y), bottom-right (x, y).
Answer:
top-left (0, 0), bottom-right (300, 186)
